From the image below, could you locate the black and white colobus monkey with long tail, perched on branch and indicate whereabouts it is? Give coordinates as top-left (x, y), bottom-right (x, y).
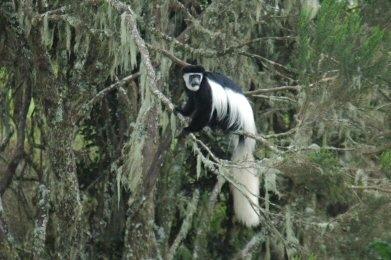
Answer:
top-left (178, 66), bottom-right (259, 227)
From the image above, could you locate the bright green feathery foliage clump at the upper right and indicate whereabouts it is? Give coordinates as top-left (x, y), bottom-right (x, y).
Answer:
top-left (296, 0), bottom-right (384, 84)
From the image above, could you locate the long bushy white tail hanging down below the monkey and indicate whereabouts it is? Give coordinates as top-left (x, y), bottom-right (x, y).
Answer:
top-left (231, 134), bottom-right (259, 227)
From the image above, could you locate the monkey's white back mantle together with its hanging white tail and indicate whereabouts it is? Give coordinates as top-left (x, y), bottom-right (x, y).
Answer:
top-left (208, 79), bottom-right (259, 227)
